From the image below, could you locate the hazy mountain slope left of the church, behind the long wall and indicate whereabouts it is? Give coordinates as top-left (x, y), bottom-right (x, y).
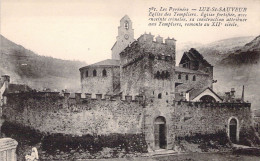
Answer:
top-left (0, 35), bottom-right (86, 92)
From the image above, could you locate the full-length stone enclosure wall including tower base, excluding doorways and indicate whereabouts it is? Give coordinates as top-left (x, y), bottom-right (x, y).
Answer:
top-left (3, 92), bottom-right (252, 152)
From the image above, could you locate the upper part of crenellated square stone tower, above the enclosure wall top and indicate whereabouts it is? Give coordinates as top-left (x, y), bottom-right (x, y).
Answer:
top-left (120, 34), bottom-right (175, 97)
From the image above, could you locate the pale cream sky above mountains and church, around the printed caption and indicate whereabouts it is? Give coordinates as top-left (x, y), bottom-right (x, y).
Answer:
top-left (0, 0), bottom-right (260, 64)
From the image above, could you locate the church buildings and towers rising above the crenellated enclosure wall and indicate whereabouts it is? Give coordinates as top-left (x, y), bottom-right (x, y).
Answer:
top-left (80, 15), bottom-right (218, 101)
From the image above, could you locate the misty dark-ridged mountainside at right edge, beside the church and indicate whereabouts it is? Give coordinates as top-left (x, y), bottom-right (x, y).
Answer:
top-left (214, 36), bottom-right (260, 109)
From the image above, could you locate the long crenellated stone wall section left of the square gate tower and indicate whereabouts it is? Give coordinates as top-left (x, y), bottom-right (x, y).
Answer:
top-left (3, 93), bottom-right (143, 136)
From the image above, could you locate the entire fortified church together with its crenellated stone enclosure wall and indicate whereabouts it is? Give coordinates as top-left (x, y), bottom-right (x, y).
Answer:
top-left (0, 16), bottom-right (252, 151)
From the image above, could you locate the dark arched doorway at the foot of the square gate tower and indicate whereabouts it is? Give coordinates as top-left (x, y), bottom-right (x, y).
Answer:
top-left (154, 116), bottom-right (167, 149)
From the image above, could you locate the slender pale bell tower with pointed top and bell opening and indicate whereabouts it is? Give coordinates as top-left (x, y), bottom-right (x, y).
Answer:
top-left (111, 15), bottom-right (135, 60)
